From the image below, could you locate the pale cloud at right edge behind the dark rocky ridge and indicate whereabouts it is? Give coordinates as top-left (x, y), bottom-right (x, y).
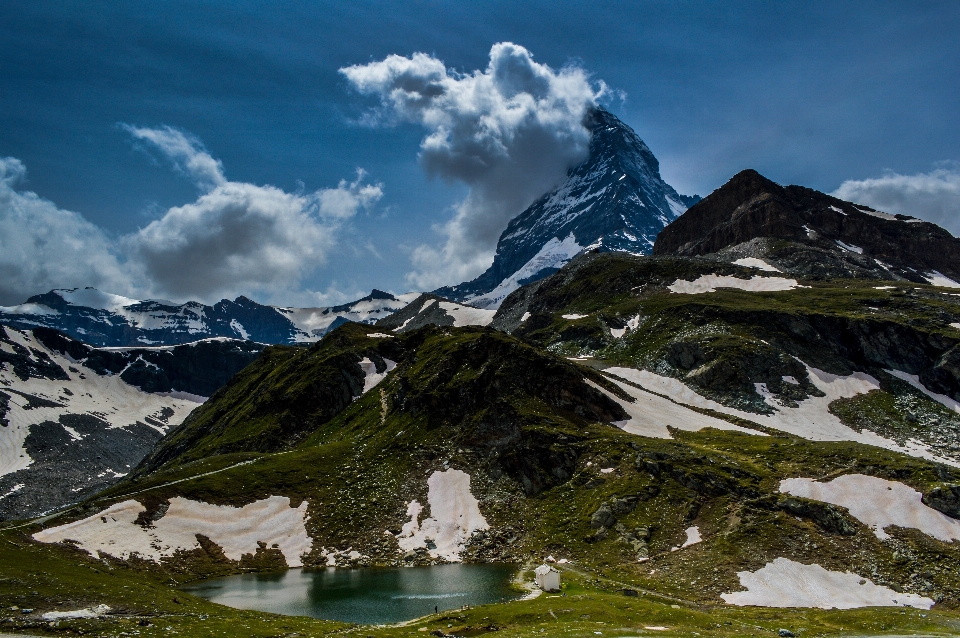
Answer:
top-left (831, 162), bottom-right (960, 236)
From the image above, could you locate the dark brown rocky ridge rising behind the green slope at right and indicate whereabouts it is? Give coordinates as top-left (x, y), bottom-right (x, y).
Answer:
top-left (653, 170), bottom-right (960, 286)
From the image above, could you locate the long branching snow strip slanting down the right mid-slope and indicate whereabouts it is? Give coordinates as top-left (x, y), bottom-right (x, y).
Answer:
top-left (604, 366), bottom-right (958, 466)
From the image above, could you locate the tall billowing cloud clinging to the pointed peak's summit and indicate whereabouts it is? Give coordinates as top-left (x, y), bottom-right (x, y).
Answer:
top-left (340, 42), bottom-right (606, 289)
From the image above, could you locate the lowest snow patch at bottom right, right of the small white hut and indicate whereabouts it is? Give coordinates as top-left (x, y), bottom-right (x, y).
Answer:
top-left (720, 558), bottom-right (933, 609)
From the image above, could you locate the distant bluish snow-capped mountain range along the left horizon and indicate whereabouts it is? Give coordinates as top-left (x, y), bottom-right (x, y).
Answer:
top-left (0, 288), bottom-right (418, 347)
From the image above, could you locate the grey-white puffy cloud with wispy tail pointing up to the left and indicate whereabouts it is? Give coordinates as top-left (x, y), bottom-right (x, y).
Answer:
top-left (123, 127), bottom-right (383, 300)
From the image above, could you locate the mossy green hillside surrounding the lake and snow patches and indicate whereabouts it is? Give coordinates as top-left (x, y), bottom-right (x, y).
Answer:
top-left (9, 254), bottom-right (960, 636)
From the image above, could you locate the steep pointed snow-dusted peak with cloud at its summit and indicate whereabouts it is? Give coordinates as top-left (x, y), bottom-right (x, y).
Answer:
top-left (435, 108), bottom-right (699, 308)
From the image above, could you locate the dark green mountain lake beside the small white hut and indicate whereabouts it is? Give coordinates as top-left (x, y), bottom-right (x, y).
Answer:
top-left (183, 564), bottom-right (517, 624)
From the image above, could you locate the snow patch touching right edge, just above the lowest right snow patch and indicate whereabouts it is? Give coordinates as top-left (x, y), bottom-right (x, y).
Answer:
top-left (780, 474), bottom-right (960, 542)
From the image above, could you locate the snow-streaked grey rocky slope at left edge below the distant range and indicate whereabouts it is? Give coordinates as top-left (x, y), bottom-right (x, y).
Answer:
top-left (0, 326), bottom-right (263, 520)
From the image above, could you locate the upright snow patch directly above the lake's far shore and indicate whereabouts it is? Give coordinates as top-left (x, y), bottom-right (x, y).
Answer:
top-left (397, 470), bottom-right (490, 561)
